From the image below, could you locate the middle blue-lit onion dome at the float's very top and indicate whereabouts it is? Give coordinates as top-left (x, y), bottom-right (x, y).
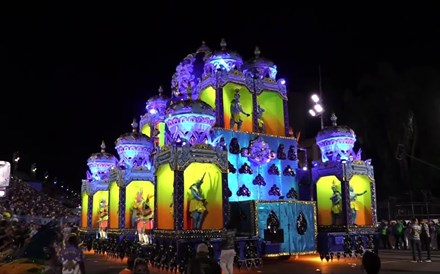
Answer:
top-left (205, 39), bottom-right (243, 74)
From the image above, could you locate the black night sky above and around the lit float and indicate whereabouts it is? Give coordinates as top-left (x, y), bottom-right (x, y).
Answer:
top-left (0, 1), bottom-right (440, 193)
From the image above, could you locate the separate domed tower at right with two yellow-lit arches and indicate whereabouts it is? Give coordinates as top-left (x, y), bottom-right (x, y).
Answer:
top-left (312, 114), bottom-right (378, 260)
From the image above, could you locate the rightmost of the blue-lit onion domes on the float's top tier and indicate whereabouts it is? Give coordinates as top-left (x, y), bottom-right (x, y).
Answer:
top-left (245, 47), bottom-right (277, 80)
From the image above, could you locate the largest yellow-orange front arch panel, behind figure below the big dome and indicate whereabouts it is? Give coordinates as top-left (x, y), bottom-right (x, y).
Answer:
top-left (184, 163), bottom-right (223, 229)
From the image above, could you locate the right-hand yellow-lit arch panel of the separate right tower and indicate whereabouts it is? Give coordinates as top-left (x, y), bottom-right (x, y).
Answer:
top-left (349, 175), bottom-right (373, 226)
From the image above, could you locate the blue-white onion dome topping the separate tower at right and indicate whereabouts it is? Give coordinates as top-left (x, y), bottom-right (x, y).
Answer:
top-left (316, 113), bottom-right (356, 162)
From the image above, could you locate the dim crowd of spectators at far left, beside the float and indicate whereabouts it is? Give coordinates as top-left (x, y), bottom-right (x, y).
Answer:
top-left (0, 179), bottom-right (79, 273)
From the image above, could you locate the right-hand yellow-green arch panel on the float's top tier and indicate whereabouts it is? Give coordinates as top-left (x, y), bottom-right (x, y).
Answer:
top-left (257, 91), bottom-right (286, 136)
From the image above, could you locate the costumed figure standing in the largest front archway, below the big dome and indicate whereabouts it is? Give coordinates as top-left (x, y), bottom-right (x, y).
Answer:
top-left (189, 172), bottom-right (206, 229)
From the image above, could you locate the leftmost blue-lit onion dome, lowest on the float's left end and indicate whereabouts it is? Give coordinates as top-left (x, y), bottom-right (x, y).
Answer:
top-left (87, 141), bottom-right (118, 181)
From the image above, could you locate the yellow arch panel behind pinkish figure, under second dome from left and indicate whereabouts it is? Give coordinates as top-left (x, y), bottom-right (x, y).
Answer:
top-left (125, 181), bottom-right (154, 228)
